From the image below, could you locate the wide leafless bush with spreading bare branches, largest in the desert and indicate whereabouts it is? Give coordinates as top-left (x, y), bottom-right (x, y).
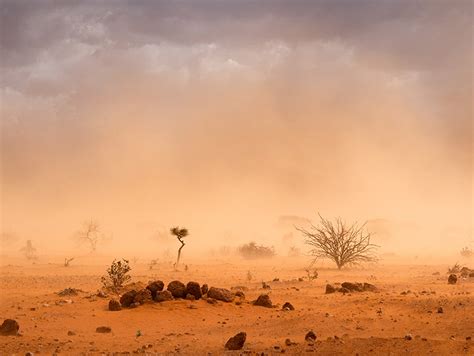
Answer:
top-left (296, 215), bottom-right (378, 269)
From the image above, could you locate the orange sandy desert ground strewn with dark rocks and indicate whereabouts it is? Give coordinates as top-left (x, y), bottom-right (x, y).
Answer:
top-left (0, 258), bottom-right (474, 355)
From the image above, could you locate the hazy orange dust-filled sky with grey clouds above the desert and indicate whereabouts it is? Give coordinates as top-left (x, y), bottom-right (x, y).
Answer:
top-left (0, 0), bottom-right (474, 252)
